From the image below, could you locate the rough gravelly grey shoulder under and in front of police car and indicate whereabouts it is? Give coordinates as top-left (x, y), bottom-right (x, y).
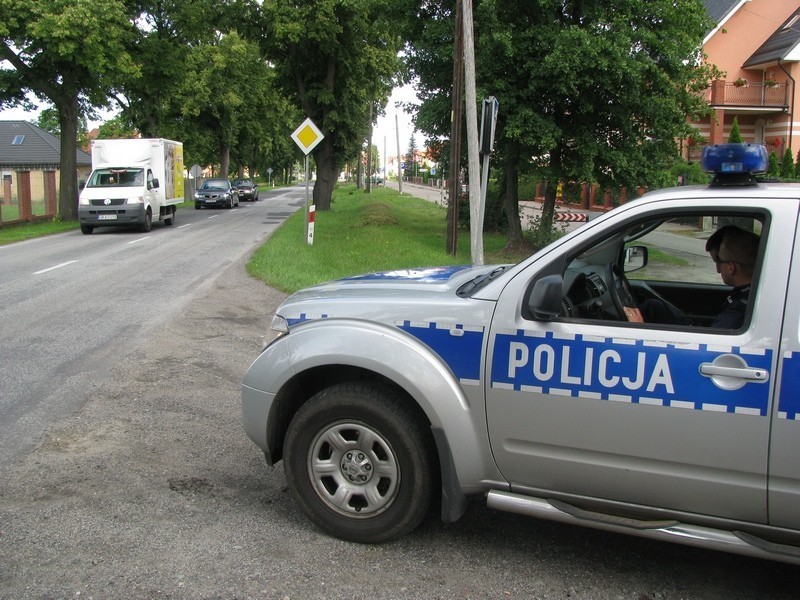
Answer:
top-left (0, 255), bottom-right (800, 600)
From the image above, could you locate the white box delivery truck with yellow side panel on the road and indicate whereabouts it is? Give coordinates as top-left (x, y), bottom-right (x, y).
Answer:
top-left (78, 139), bottom-right (184, 234)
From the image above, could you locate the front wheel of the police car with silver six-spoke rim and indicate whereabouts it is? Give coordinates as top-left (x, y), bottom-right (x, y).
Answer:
top-left (283, 383), bottom-right (435, 543)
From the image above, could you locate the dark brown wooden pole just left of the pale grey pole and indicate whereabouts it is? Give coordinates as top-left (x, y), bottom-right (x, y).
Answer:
top-left (447, 0), bottom-right (464, 256)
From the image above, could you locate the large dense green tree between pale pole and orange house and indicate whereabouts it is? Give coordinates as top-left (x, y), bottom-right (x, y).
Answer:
top-left (411, 0), bottom-right (715, 241)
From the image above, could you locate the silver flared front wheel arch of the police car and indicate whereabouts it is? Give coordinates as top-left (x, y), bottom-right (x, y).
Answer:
top-left (245, 319), bottom-right (500, 522)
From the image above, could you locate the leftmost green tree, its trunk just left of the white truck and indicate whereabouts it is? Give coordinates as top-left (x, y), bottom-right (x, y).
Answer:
top-left (0, 0), bottom-right (136, 219)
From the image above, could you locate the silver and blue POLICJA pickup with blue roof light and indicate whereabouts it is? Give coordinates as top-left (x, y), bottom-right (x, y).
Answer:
top-left (242, 144), bottom-right (800, 564)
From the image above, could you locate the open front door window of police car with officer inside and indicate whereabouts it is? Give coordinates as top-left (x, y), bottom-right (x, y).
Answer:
top-left (562, 212), bottom-right (766, 333)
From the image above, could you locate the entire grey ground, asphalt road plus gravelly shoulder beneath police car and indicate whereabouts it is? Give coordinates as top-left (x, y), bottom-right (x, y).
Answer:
top-left (0, 185), bottom-right (800, 600)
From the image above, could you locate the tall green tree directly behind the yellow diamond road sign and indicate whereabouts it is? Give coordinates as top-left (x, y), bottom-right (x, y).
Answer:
top-left (262, 0), bottom-right (400, 211)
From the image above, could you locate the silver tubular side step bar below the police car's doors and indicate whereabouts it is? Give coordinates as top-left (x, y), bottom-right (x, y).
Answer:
top-left (486, 490), bottom-right (800, 565)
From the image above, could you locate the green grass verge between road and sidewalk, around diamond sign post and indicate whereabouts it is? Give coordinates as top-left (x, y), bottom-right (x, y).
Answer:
top-left (247, 185), bottom-right (529, 293)
